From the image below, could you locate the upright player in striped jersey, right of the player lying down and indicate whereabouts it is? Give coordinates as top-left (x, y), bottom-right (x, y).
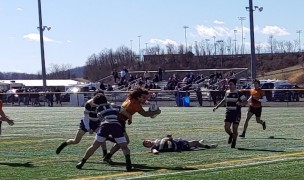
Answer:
top-left (213, 79), bottom-right (247, 148)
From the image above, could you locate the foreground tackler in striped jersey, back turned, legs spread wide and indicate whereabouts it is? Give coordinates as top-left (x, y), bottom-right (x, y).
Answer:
top-left (76, 94), bottom-right (132, 171)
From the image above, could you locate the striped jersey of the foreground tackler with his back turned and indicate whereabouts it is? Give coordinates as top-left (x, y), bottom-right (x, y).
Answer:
top-left (97, 104), bottom-right (123, 123)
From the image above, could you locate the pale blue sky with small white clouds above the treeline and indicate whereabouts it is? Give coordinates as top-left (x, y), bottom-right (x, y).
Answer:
top-left (0, 0), bottom-right (304, 73)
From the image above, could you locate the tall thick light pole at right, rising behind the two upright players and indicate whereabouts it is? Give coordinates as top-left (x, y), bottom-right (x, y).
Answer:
top-left (246, 0), bottom-right (263, 79)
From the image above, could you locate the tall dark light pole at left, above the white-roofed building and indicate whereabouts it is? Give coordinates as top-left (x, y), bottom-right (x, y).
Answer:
top-left (38, 0), bottom-right (51, 91)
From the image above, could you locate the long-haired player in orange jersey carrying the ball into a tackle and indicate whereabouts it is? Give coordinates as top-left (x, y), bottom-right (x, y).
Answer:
top-left (103, 88), bottom-right (161, 164)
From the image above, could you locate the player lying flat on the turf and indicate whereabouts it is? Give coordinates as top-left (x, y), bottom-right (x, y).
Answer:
top-left (143, 135), bottom-right (218, 154)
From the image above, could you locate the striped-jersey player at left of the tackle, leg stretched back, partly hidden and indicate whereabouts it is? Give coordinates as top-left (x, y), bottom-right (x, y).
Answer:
top-left (56, 90), bottom-right (107, 156)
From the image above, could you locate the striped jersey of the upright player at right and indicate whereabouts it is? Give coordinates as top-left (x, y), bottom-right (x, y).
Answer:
top-left (225, 90), bottom-right (246, 112)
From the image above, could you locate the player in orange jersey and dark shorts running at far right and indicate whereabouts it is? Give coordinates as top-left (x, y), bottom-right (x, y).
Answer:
top-left (240, 79), bottom-right (266, 137)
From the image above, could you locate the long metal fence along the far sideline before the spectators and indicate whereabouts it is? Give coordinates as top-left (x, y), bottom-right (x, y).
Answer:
top-left (0, 89), bottom-right (304, 107)
